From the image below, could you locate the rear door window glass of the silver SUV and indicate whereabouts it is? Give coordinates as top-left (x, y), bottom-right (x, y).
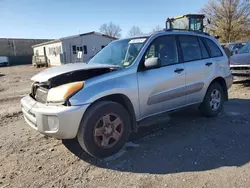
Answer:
top-left (179, 36), bottom-right (201, 62)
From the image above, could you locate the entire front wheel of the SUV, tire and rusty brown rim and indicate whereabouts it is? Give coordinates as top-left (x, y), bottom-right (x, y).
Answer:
top-left (77, 101), bottom-right (131, 158)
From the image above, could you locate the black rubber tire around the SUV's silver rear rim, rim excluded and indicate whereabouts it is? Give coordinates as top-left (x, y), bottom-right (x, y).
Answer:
top-left (200, 82), bottom-right (225, 117)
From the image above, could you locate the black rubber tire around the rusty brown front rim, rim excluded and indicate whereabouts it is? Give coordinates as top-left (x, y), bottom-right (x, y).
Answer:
top-left (77, 101), bottom-right (131, 158)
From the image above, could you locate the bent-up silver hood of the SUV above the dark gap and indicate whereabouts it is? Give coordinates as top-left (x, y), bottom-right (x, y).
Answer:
top-left (31, 63), bottom-right (119, 82)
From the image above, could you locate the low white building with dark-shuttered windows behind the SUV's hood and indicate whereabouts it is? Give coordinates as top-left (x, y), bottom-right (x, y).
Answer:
top-left (32, 31), bottom-right (116, 66)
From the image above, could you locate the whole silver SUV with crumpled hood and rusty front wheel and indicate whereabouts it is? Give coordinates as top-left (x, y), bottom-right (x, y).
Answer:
top-left (21, 31), bottom-right (232, 158)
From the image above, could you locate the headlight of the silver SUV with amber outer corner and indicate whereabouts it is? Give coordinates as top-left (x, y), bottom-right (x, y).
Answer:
top-left (47, 82), bottom-right (84, 103)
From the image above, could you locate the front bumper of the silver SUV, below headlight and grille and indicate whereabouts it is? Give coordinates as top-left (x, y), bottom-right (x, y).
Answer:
top-left (21, 96), bottom-right (89, 139)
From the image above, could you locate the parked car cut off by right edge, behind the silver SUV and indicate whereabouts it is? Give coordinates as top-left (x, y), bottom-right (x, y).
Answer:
top-left (230, 42), bottom-right (250, 78)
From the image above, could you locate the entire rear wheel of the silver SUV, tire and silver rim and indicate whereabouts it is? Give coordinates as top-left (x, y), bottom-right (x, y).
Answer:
top-left (200, 83), bottom-right (224, 117)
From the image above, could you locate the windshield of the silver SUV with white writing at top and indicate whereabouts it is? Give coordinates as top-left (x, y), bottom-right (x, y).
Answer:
top-left (89, 38), bottom-right (147, 67)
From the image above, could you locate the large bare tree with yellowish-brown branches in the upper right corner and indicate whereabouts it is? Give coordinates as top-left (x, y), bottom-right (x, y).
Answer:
top-left (201, 0), bottom-right (250, 42)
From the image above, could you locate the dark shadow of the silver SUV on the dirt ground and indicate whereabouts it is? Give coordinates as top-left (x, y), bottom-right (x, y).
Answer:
top-left (63, 99), bottom-right (250, 174)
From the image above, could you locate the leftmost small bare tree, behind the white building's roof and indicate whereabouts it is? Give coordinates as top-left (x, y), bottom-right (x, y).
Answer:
top-left (99, 22), bottom-right (122, 38)
